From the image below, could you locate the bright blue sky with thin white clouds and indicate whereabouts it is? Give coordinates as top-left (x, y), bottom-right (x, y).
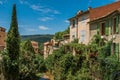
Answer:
top-left (0, 0), bottom-right (117, 35)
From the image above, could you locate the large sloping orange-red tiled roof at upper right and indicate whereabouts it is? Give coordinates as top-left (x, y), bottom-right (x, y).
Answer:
top-left (90, 1), bottom-right (120, 21)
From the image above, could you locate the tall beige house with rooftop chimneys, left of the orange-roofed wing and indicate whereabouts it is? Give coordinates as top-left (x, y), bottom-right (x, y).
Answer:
top-left (69, 8), bottom-right (91, 44)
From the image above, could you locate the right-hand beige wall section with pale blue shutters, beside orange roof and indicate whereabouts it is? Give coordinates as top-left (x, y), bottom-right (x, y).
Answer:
top-left (78, 14), bottom-right (90, 44)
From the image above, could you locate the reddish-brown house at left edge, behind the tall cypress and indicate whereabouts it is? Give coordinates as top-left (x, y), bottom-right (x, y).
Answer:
top-left (0, 27), bottom-right (6, 51)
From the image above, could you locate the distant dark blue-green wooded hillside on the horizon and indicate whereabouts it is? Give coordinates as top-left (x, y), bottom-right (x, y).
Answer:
top-left (21, 34), bottom-right (53, 43)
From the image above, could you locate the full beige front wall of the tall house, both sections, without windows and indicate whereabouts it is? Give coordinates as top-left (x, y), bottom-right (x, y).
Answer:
top-left (70, 13), bottom-right (90, 44)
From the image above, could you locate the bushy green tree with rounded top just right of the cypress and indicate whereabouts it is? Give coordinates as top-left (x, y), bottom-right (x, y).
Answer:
top-left (19, 40), bottom-right (45, 80)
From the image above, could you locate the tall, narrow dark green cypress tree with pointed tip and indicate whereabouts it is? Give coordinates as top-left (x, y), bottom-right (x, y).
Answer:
top-left (6, 4), bottom-right (20, 80)
